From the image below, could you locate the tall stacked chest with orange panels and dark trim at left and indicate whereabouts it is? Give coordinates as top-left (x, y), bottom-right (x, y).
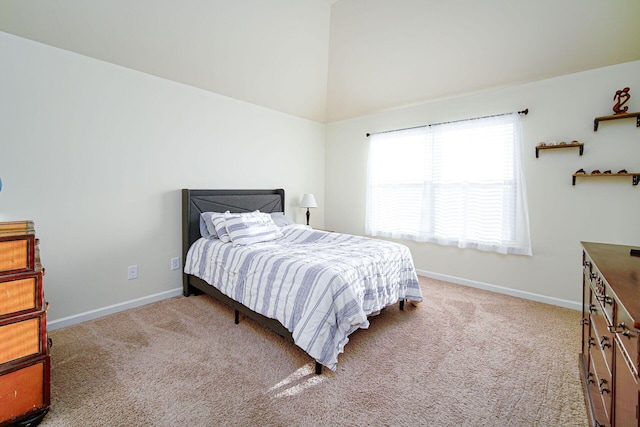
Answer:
top-left (0, 221), bottom-right (50, 426)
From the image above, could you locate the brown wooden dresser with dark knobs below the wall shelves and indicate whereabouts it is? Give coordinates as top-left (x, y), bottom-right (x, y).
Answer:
top-left (580, 242), bottom-right (640, 427)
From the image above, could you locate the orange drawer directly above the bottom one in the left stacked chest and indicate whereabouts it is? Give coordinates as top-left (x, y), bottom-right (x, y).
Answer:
top-left (0, 311), bottom-right (47, 368)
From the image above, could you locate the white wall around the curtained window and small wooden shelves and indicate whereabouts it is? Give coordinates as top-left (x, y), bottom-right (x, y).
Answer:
top-left (325, 61), bottom-right (640, 306)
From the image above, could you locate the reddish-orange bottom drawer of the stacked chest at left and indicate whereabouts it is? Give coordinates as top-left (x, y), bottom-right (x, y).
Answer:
top-left (0, 356), bottom-right (50, 425)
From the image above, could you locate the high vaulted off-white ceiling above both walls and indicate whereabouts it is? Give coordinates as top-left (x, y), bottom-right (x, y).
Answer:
top-left (0, 0), bottom-right (640, 122)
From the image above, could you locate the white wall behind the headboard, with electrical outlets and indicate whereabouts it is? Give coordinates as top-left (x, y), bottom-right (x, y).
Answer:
top-left (0, 32), bottom-right (325, 321)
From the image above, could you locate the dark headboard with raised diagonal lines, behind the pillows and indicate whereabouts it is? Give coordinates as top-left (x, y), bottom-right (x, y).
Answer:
top-left (182, 188), bottom-right (284, 265)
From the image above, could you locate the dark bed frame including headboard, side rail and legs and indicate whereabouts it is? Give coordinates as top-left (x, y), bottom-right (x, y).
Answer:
top-left (182, 189), bottom-right (404, 375)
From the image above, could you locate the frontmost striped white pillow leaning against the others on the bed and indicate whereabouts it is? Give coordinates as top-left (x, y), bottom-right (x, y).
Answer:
top-left (224, 211), bottom-right (282, 246)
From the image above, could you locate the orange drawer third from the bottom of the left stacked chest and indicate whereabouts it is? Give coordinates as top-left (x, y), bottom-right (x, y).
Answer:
top-left (0, 273), bottom-right (42, 319)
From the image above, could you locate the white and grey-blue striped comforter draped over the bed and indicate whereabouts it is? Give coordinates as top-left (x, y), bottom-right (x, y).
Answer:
top-left (184, 225), bottom-right (422, 371)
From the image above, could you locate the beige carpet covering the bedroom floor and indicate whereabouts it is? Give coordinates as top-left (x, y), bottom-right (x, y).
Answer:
top-left (41, 278), bottom-right (588, 427)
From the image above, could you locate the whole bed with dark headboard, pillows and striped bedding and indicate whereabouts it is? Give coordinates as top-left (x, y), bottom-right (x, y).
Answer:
top-left (182, 189), bottom-right (422, 374)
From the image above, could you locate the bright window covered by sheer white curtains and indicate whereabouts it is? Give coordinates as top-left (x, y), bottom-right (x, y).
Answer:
top-left (366, 113), bottom-right (532, 255)
